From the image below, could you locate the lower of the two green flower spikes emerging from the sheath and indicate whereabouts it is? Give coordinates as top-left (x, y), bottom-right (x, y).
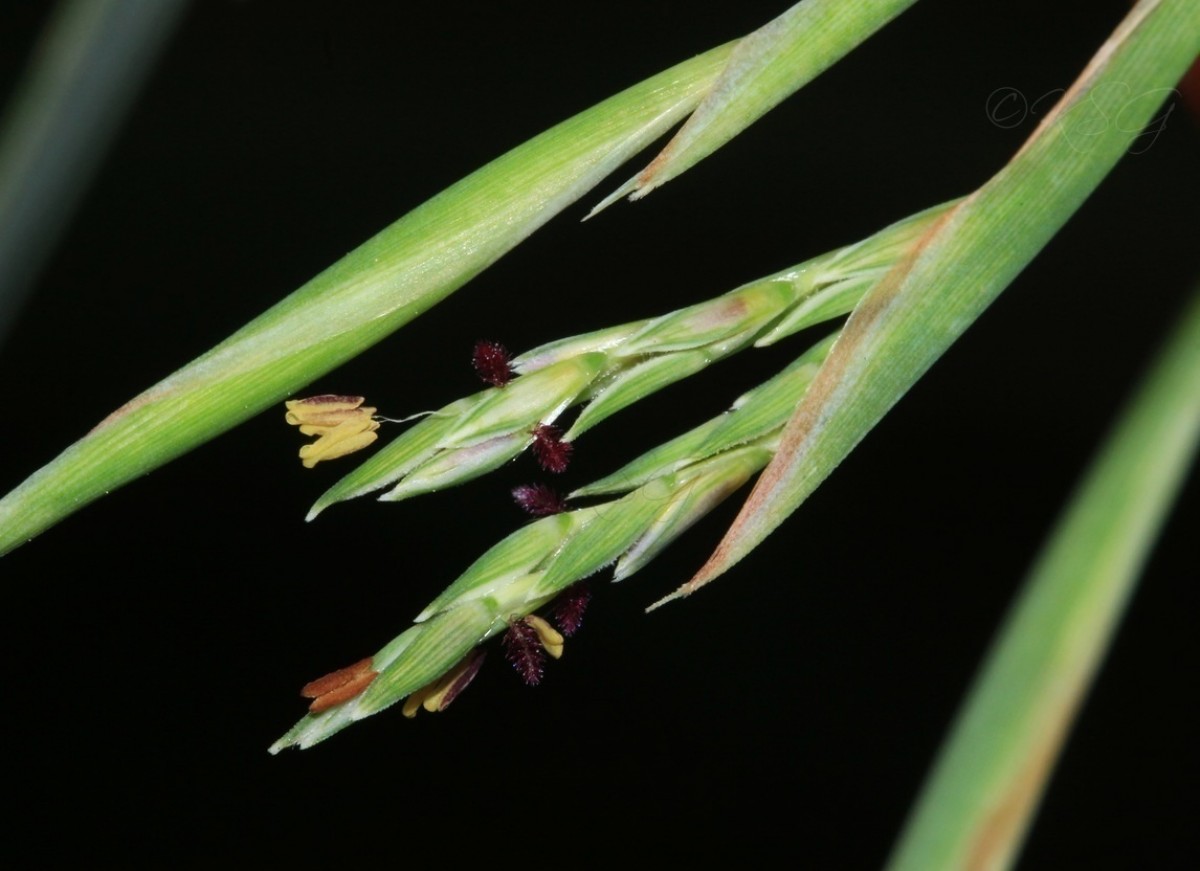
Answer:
top-left (271, 335), bottom-right (836, 752)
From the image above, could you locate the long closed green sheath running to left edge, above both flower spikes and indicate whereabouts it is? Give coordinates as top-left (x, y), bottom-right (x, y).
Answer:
top-left (0, 40), bottom-right (731, 554)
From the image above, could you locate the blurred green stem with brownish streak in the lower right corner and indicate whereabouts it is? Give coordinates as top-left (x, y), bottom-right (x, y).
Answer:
top-left (888, 286), bottom-right (1200, 871)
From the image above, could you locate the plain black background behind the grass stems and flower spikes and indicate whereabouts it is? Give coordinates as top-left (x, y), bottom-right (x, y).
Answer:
top-left (0, 0), bottom-right (1200, 869)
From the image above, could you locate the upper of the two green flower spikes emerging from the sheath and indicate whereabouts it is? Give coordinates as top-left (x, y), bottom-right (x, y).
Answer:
top-left (308, 203), bottom-right (953, 519)
